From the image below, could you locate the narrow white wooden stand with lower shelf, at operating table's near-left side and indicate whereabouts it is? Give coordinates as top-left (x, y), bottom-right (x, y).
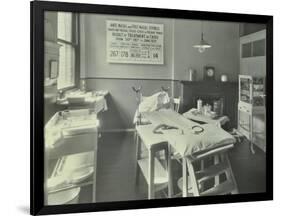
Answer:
top-left (136, 125), bottom-right (173, 199)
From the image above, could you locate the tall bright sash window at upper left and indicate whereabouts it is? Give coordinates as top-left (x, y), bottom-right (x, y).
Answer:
top-left (57, 12), bottom-right (78, 89)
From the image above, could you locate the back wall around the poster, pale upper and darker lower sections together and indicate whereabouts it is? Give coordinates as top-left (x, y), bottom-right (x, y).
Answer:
top-left (80, 14), bottom-right (173, 129)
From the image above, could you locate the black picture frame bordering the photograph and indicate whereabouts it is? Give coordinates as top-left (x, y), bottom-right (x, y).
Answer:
top-left (30, 1), bottom-right (273, 215)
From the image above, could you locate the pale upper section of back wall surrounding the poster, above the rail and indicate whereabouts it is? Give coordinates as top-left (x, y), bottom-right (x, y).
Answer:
top-left (81, 14), bottom-right (173, 79)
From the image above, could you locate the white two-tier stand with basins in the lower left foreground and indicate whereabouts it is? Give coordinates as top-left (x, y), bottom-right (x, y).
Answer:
top-left (44, 109), bottom-right (99, 205)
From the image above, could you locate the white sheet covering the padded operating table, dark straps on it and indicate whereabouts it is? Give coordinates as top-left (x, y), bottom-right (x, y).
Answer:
top-left (144, 109), bottom-right (235, 156)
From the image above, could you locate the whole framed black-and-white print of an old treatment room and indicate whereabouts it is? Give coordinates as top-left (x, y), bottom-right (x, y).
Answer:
top-left (30, 1), bottom-right (273, 215)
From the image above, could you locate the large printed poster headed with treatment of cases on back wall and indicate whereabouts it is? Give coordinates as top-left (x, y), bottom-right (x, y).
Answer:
top-left (106, 20), bottom-right (164, 64)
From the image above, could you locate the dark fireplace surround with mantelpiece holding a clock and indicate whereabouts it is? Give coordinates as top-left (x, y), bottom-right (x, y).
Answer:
top-left (180, 81), bottom-right (238, 128)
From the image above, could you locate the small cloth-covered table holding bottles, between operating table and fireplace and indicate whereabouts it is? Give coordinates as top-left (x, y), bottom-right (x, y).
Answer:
top-left (183, 108), bottom-right (229, 127)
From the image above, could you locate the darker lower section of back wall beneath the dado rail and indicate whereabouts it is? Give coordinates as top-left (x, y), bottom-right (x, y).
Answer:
top-left (87, 79), bottom-right (171, 129)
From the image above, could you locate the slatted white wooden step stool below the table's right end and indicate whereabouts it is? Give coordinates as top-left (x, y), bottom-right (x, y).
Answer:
top-left (179, 144), bottom-right (238, 196)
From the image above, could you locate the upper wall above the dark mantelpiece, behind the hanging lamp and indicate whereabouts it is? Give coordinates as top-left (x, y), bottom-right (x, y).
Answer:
top-left (174, 20), bottom-right (239, 81)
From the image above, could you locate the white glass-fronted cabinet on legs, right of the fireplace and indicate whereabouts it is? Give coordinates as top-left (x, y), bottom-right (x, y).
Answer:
top-left (238, 75), bottom-right (266, 153)
